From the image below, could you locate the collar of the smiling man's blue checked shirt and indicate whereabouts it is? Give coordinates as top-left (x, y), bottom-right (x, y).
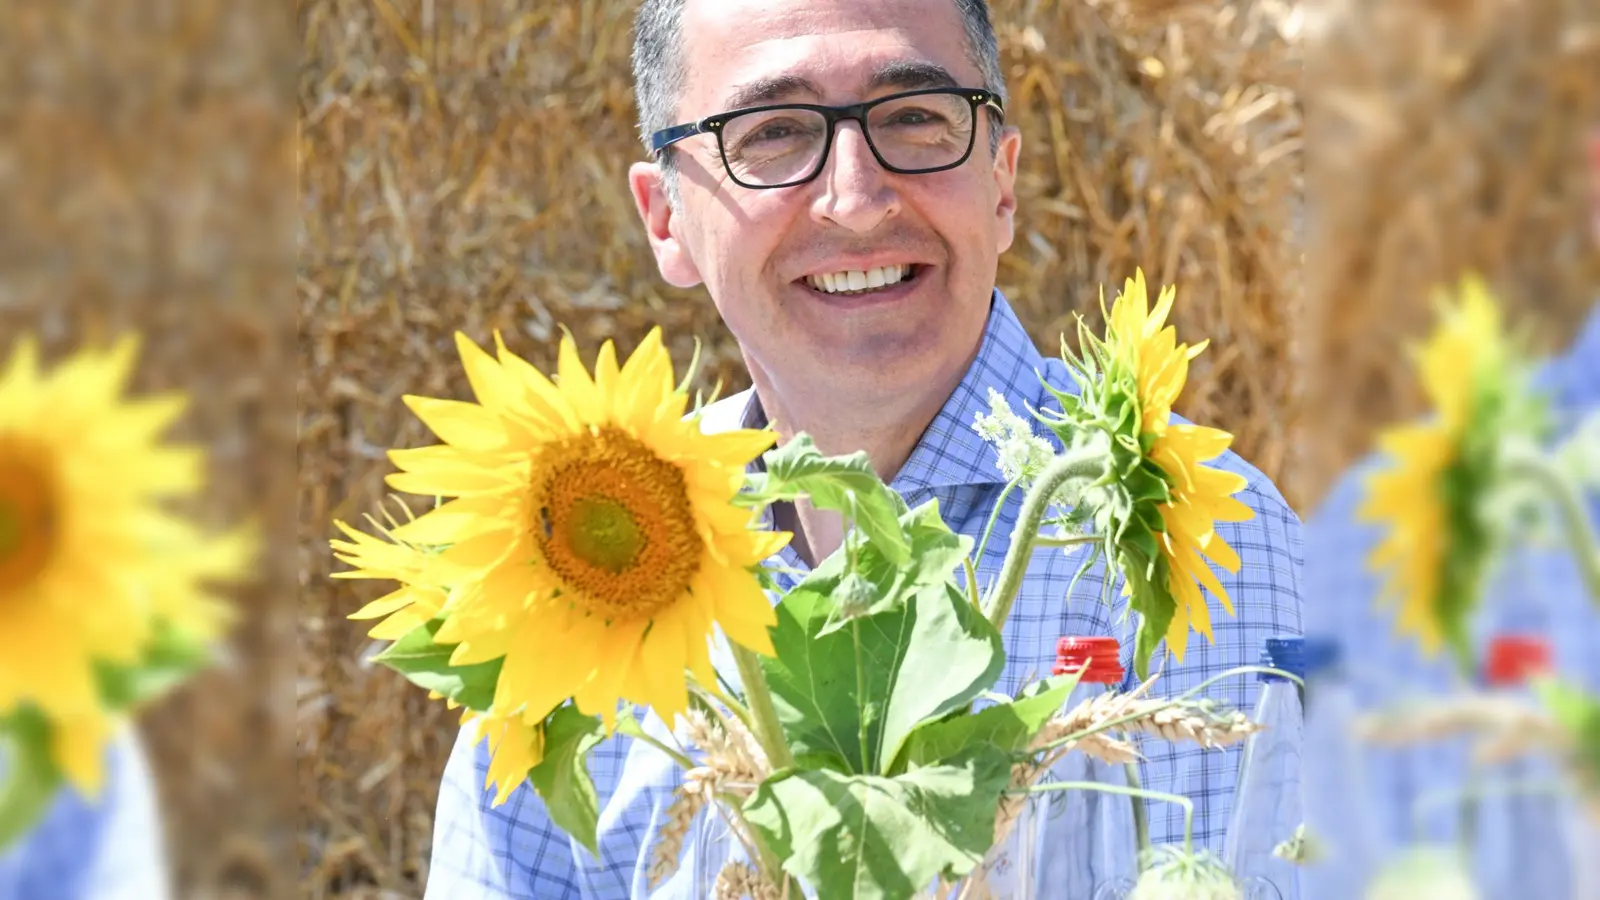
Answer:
top-left (730, 288), bottom-right (1077, 495)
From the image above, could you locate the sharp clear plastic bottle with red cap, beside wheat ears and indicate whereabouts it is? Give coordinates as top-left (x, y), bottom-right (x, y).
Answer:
top-left (1019, 637), bottom-right (1144, 900)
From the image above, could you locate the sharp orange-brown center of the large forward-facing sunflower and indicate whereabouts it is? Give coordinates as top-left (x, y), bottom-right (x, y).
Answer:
top-left (533, 429), bottom-right (704, 621)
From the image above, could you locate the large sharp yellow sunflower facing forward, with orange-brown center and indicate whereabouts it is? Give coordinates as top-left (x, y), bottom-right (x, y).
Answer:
top-left (369, 330), bottom-right (789, 729)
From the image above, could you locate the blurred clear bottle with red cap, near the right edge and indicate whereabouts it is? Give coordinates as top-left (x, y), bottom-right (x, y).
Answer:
top-left (1469, 634), bottom-right (1578, 900)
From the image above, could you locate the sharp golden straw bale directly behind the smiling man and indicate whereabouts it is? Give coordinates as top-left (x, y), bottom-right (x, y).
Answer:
top-left (298, 0), bottom-right (1299, 898)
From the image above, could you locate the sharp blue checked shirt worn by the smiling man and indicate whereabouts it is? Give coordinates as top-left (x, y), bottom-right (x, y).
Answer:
top-left (427, 291), bottom-right (1301, 900)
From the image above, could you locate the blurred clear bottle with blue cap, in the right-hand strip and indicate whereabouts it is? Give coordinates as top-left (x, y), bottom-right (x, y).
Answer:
top-left (1301, 637), bottom-right (1381, 900)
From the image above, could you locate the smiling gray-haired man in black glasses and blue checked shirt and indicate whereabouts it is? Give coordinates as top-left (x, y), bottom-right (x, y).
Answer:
top-left (427, 0), bottom-right (1301, 900)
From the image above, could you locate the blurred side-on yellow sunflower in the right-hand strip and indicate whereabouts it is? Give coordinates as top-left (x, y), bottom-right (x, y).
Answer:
top-left (1358, 275), bottom-right (1515, 665)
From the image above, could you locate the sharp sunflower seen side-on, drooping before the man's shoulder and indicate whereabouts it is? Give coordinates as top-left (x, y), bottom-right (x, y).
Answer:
top-left (1046, 271), bottom-right (1253, 677)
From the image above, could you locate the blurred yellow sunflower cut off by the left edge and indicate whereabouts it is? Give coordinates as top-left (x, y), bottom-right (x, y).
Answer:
top-left (0, 338), bottom-right (253, 796)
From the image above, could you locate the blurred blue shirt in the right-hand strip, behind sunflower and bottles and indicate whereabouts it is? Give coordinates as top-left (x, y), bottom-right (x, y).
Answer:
top-left (1306, 304), bottom-right (1600, 847)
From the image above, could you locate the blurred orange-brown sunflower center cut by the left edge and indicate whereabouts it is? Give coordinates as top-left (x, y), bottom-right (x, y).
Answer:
top-left (0, 434), bottom-right (56, 601)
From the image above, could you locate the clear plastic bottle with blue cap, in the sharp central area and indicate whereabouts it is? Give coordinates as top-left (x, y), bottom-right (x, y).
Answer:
top-left (1222, 637), bottom-right (1306, 900)
